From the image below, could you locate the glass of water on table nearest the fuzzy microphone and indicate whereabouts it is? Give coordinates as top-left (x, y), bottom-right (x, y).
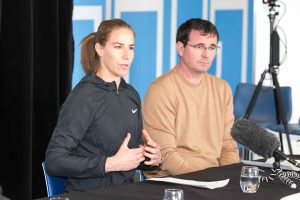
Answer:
top-left (240, 166), bottom-right (260, 193)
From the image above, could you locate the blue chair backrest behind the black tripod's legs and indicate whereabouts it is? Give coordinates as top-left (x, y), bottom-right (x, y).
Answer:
top-left (234, 83), bottom-right (292, 124)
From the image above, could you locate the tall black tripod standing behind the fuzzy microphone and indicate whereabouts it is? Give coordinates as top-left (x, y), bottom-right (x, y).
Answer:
top-left (244, 0), bottom-right (293, 160)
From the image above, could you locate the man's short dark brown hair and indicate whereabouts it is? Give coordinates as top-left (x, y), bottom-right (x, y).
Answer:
top-left (176, 18), bottom-right (219, 46)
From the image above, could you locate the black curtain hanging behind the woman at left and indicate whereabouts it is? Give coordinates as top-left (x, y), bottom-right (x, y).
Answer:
top-left (0, 0), bottom-right (74, 200)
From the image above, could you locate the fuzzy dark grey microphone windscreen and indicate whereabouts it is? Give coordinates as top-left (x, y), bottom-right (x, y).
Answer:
top-left (231, 119), bottom-right (280, 159)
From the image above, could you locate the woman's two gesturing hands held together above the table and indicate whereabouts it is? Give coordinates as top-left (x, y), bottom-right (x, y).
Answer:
top-left (105, 129), bottom-right (162, 172)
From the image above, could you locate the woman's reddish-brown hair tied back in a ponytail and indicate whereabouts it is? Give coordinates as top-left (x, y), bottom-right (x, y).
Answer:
top-left (80, 19), bottom-right (134, 73)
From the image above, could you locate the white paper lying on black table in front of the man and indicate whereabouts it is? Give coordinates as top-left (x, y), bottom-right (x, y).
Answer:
top-left (147, 177), bottom-right (229, 189)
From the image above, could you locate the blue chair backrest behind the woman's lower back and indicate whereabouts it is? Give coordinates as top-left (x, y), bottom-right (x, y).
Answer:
top-left (42, 161), bottom-right (67, 197)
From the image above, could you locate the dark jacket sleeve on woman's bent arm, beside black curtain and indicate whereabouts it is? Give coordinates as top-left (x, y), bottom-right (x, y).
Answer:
top-left (46, 89), bottom-right (106, 178)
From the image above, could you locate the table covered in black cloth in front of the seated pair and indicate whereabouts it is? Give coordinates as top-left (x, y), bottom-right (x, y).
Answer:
top-left (36, 163), bottom-right (300, 200)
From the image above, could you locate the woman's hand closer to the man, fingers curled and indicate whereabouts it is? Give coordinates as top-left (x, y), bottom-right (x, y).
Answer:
top-left (142, 129), bottom-right (162, 166)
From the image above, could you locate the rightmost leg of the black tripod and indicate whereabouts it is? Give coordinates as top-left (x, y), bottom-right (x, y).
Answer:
top-left (271, 70), bottom-right (293, 155)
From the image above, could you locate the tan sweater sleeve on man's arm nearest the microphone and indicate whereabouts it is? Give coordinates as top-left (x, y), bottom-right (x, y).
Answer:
top-left (219, 84), bottom-right (240, 166)
